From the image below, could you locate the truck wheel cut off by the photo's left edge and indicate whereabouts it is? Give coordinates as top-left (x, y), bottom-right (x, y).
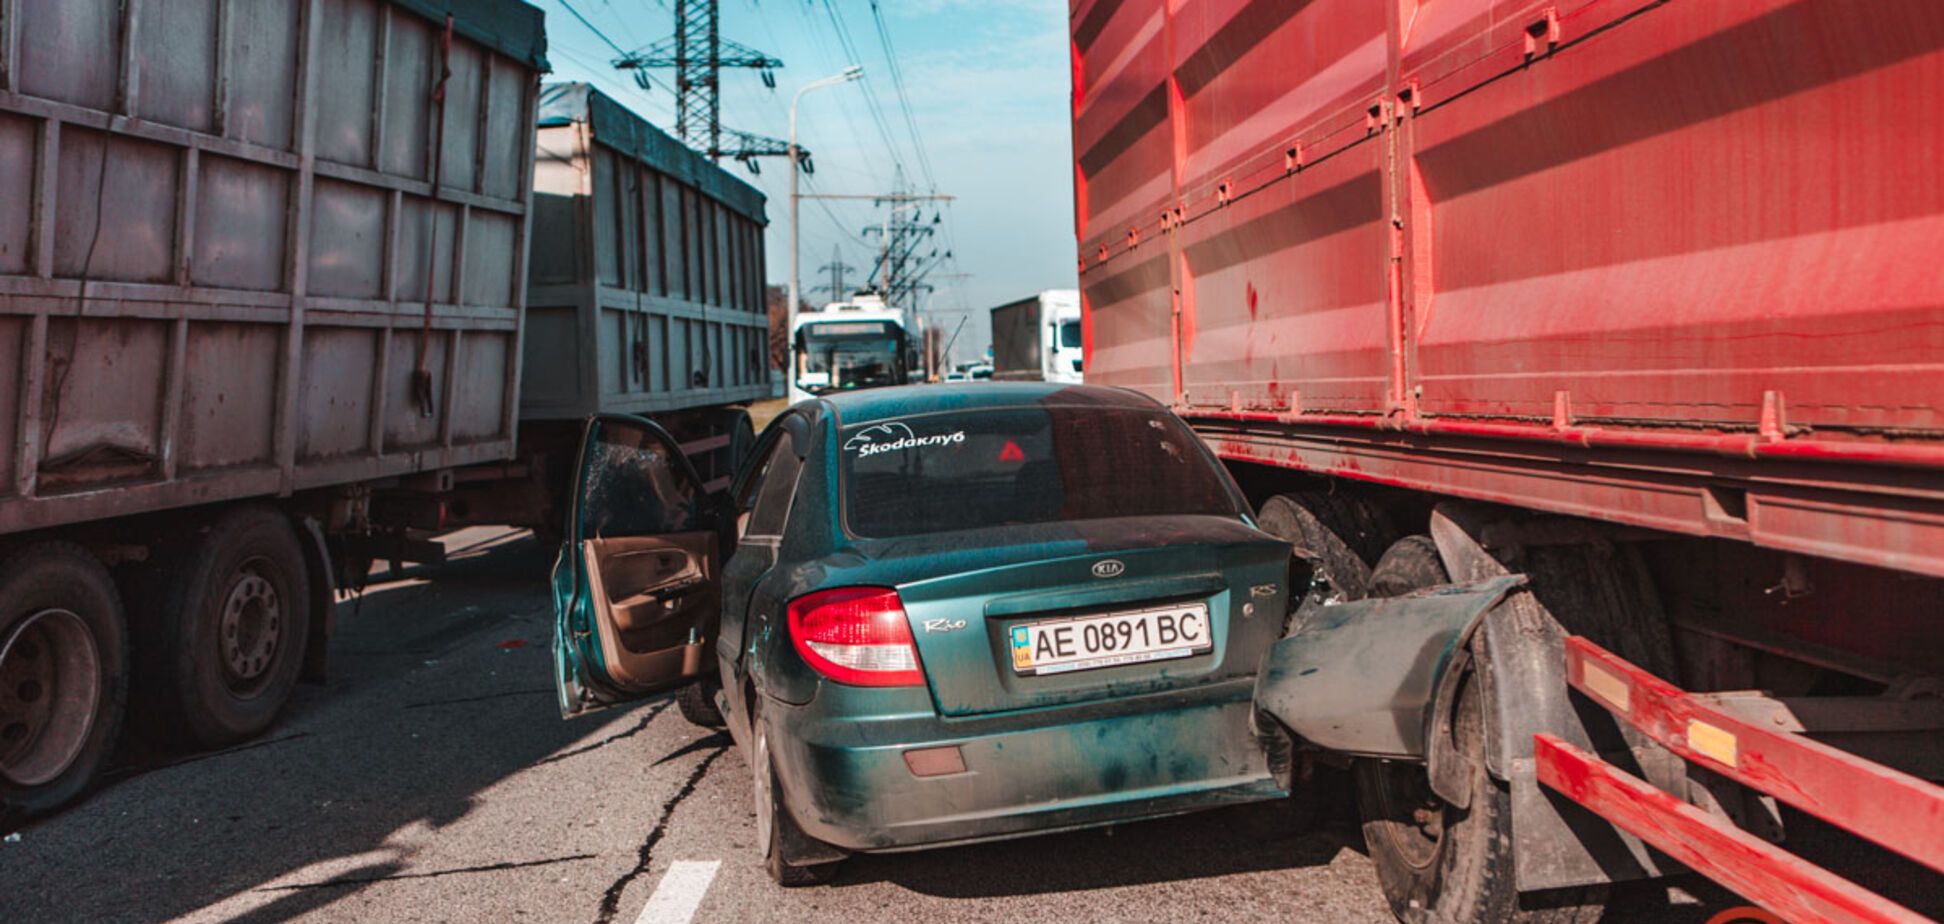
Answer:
top-left (0, 543), bottom-right (128, 815)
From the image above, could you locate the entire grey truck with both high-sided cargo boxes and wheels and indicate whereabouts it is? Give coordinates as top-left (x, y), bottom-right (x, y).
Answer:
top-left (0, 0), bottom-right (770, 813)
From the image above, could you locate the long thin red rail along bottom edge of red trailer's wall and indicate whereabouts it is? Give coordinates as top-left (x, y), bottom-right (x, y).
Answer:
top-left (1180, 407), bottom-right (1944, 469)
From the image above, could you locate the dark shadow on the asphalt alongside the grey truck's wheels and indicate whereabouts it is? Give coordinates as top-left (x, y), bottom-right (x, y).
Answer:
top-left (0, 539), bottom-right (669, 922)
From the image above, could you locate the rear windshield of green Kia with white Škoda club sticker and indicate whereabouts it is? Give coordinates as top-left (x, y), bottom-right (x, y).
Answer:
top-left (840, 405), bottom-right (1240, 537)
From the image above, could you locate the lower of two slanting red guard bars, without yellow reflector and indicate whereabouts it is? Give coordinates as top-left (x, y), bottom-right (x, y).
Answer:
top-left (1532, 735), bottom-right (1927, 922)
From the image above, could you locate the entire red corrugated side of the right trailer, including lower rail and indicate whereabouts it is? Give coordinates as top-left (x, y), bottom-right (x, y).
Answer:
top-left (1071, 0), bottom-right (1944, 574)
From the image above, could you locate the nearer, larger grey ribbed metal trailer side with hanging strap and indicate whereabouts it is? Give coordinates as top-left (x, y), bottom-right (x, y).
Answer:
top-left (0, 0), bottom-right (546, 533)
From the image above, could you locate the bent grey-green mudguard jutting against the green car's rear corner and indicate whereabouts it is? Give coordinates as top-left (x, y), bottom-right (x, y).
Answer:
top-left (1256, 574), bottom-right (1526, 761)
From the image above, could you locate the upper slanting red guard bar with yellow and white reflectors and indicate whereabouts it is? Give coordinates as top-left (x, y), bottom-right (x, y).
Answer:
top-left (1567, 636), bottom-right (1944, 871)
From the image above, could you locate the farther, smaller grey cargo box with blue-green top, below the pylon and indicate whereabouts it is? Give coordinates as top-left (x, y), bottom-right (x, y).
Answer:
top-left (521, 84), bottom-right (772, 420)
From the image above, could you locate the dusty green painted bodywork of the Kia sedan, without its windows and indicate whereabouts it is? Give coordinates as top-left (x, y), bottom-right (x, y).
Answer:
top-left (556, 383), bottom-right (1289, 850)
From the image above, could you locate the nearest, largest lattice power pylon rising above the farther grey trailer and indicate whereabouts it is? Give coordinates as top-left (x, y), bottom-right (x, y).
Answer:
top-left (612, 0), bottom-right (811, 173)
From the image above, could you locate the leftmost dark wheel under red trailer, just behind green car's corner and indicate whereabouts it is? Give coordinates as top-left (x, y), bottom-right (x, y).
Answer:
top-left (1256, 490), bottom-right (1394, 609)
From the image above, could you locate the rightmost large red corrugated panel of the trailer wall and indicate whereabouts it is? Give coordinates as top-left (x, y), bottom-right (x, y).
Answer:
top-left (1413, 2), bottom-right (1944, 430)
